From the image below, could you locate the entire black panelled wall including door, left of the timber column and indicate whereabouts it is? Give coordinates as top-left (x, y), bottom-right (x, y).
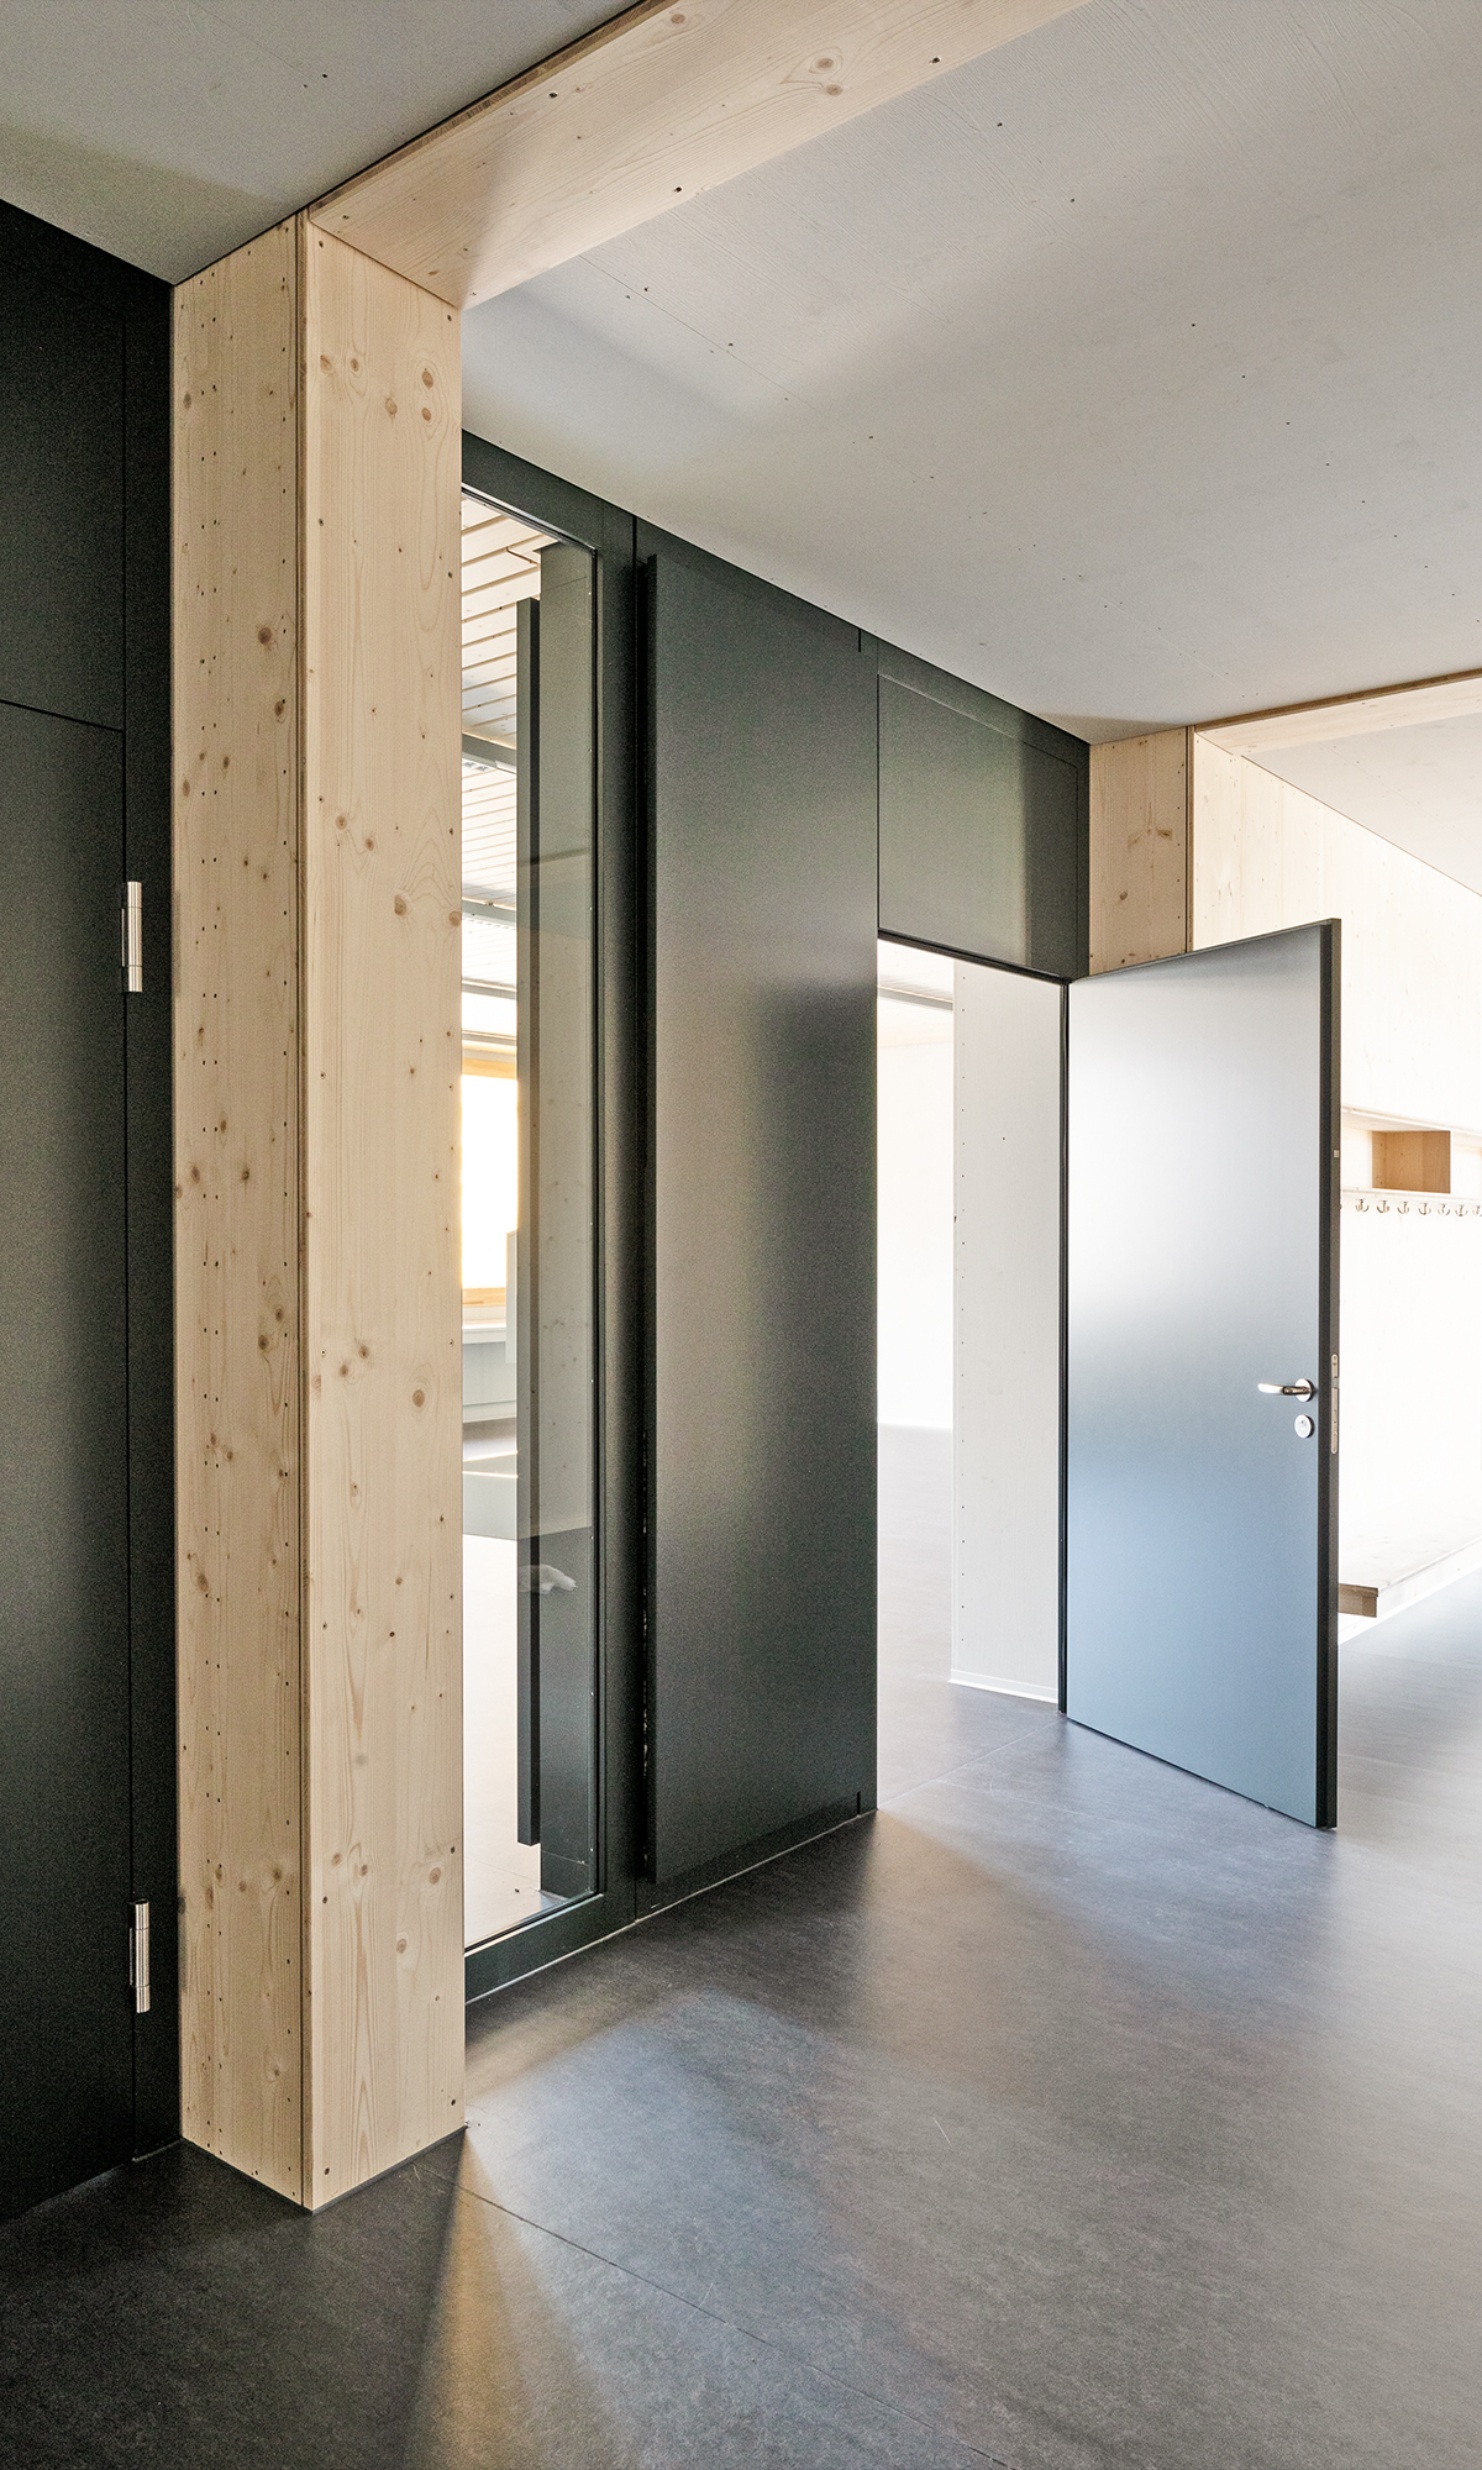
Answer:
top-left (0, 205), bottom-right (180, 2201)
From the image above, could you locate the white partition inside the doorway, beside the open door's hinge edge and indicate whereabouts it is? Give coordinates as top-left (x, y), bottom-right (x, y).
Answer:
top-left (951, 961), bottom-right (1062, 1699)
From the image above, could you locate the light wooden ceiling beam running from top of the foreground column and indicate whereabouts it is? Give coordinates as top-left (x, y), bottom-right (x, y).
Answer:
top-left (311, 0), bottom-right (1084, 309)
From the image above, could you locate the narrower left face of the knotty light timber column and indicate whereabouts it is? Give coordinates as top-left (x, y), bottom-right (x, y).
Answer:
top-left (173, 225), bottom-right (304, 2198)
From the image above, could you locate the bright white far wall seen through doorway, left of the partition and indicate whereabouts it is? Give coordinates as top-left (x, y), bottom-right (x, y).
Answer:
top-left (877, 995), bottom-right (953, 1433)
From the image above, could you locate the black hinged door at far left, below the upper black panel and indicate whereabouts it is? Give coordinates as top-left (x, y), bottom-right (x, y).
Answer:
top-left (0, 704), bottom-right (133, 2216)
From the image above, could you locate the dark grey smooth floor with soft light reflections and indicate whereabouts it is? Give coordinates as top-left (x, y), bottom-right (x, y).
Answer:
top-left (0, 1462), bottom-right (1482, 2470)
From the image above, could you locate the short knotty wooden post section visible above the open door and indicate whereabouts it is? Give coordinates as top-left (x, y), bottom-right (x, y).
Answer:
top-left (1092, 729), bottom-right (1188, 973)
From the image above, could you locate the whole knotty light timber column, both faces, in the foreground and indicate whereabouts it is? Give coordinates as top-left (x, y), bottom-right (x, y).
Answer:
top-left (175, 217), bottom-right (462, 2206)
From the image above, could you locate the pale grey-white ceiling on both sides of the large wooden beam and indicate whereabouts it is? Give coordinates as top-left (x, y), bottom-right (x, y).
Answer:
top-left (0, 0), bottom-right (1482, 780)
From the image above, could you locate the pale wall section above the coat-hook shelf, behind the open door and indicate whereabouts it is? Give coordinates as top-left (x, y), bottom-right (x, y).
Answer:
top-left (1191, 734), bottom-right (1482, 1126)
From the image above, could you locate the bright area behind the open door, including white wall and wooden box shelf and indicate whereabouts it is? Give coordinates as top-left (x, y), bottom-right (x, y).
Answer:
top-left (1191, 716), bottom-right (1482, 1640)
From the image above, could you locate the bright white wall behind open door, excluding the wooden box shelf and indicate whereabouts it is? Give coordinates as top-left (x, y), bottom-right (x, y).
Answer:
top-left (1191, 736), bottom-right (1482, 1588)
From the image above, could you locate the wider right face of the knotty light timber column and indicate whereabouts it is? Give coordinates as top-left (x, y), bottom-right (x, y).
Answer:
top-left (304, 222), bottom-right (464, 2203)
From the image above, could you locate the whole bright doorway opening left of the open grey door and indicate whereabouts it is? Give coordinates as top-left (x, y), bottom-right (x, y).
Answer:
top-left (877, 941), bottom-right (1062, 1801)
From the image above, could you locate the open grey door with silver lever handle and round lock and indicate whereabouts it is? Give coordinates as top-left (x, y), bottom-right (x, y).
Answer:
top-left (1065, 921), bottom-right (1339, 1828)
